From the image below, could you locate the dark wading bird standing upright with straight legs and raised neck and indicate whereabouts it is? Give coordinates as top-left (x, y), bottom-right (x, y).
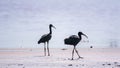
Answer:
top-left (38, 24), bottom-right (55, 56)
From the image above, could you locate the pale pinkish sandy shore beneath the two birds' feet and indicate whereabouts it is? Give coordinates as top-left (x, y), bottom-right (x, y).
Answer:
top-left (0, 48), bottom-right (120, 68)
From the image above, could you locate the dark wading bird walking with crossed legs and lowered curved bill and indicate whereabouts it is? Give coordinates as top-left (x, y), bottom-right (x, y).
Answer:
top-left (64, 32), bottom-right (88, 60)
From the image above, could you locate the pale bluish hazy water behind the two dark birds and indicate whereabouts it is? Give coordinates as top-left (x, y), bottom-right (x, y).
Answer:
top-left (0, 0), bottom-right (120, 48)
